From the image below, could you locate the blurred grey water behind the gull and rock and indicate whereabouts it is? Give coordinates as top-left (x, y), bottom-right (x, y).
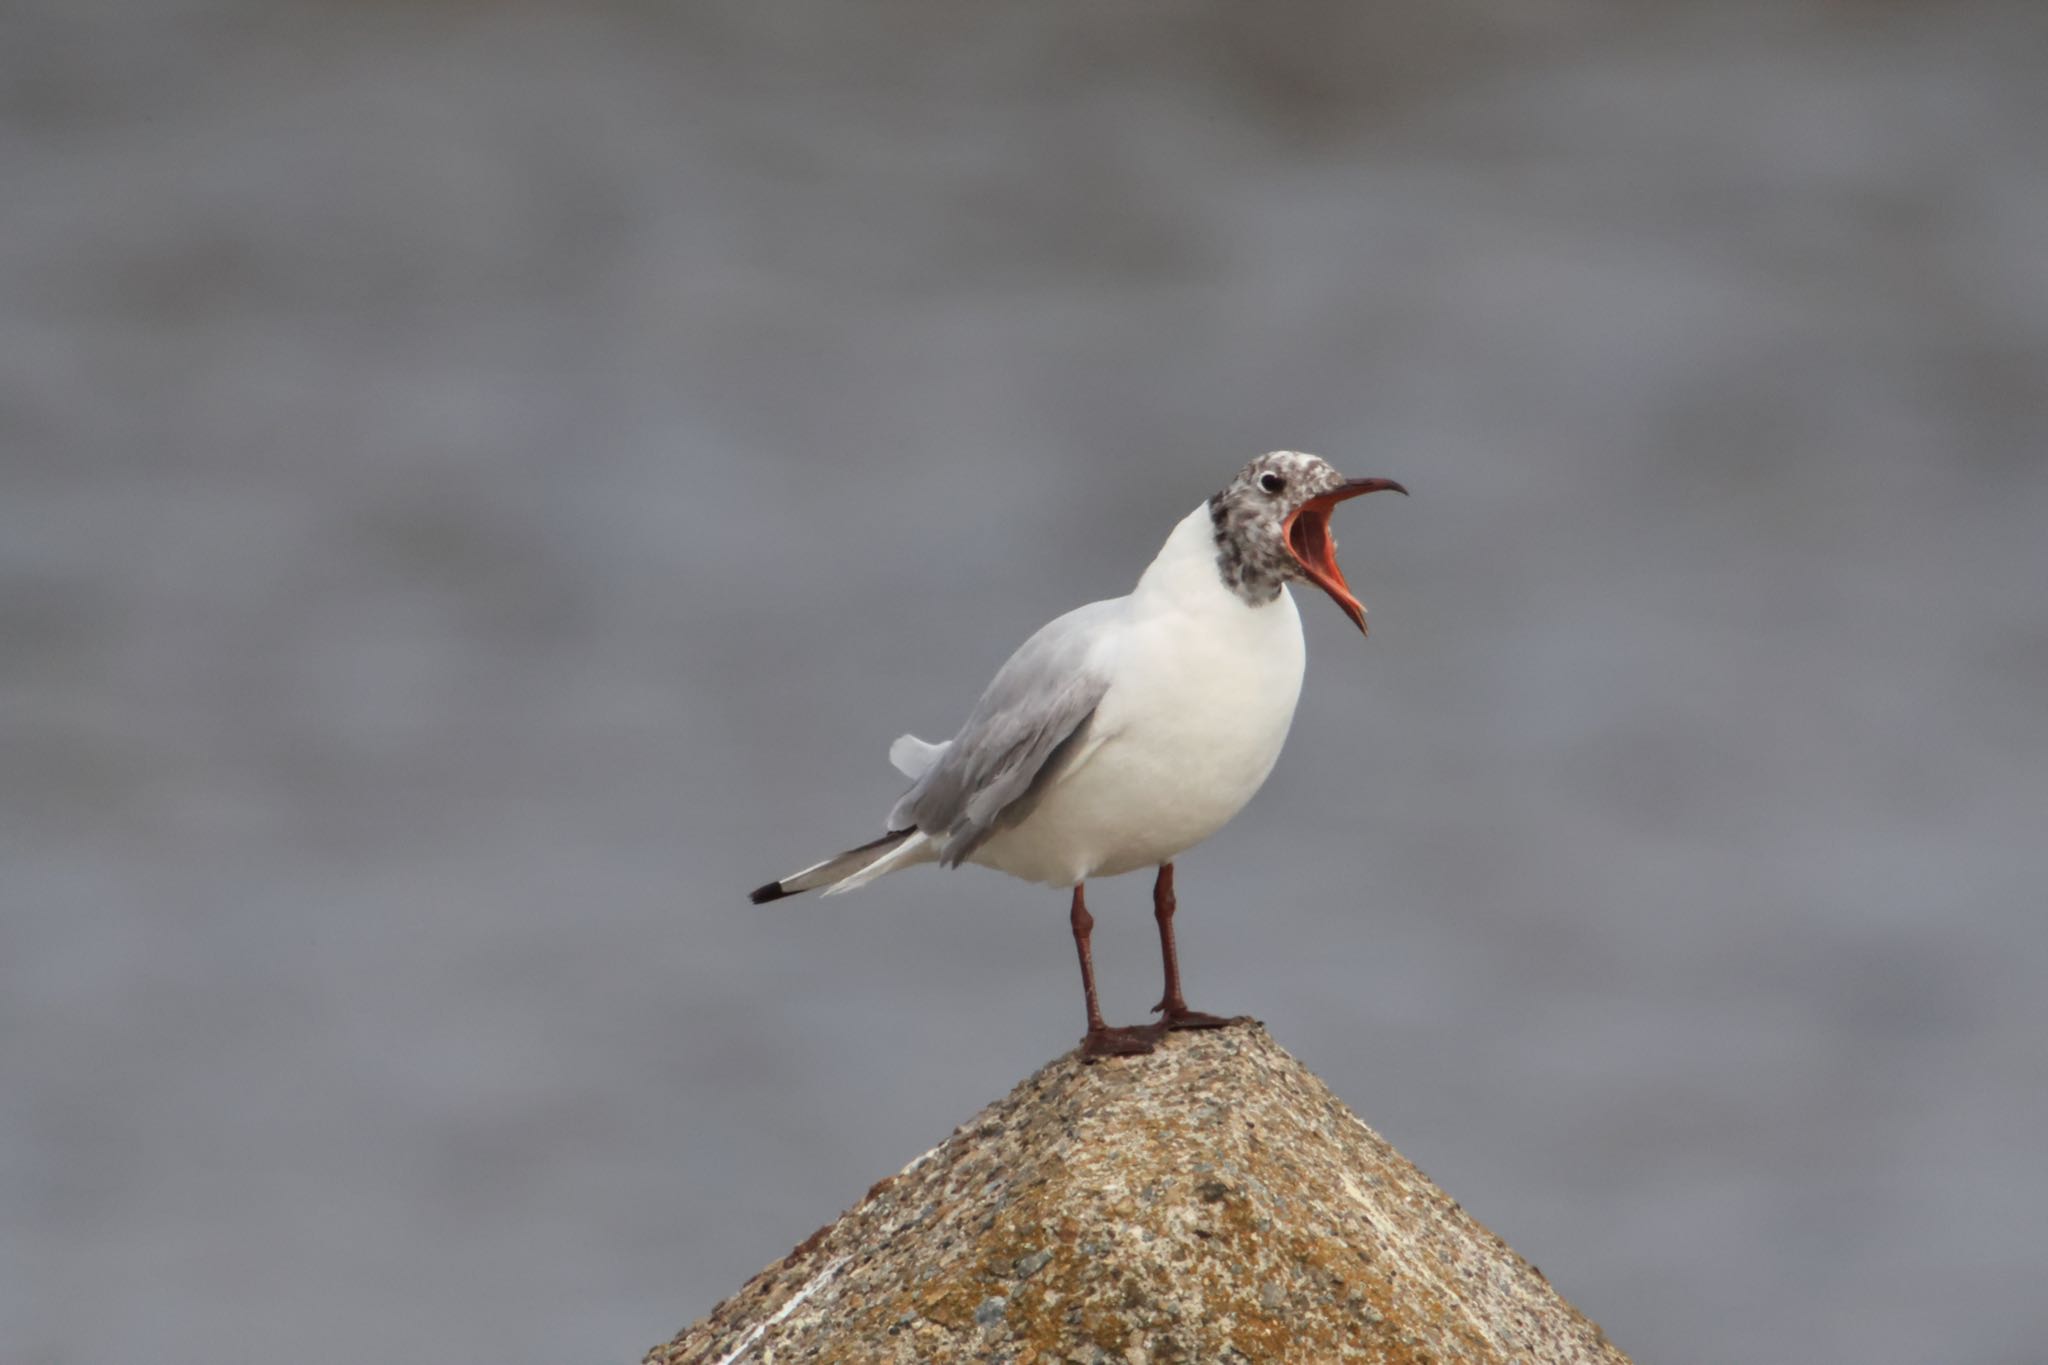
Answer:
top-left (0, 0), bottom-right (2048, 1365)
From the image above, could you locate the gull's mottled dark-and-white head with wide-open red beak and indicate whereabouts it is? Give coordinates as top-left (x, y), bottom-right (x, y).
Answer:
top-left (1208, 450), bottom-right (1407, 630)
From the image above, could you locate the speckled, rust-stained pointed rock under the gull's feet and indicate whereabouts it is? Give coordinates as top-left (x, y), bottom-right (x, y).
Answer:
top-left (647, 1023), bottom-right (1626, 1365)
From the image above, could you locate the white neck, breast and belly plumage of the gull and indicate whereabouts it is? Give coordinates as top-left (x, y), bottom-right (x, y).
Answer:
top-left (973, 503), bottom-right (1305, 886)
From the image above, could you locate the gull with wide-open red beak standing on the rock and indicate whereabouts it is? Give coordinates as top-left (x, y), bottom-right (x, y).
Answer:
top-left (752, 450), bottom-right (1407, 1060)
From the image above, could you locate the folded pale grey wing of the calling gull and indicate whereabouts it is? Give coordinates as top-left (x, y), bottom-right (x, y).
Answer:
top-left (889, 598), bottom-right (1124, 868)
